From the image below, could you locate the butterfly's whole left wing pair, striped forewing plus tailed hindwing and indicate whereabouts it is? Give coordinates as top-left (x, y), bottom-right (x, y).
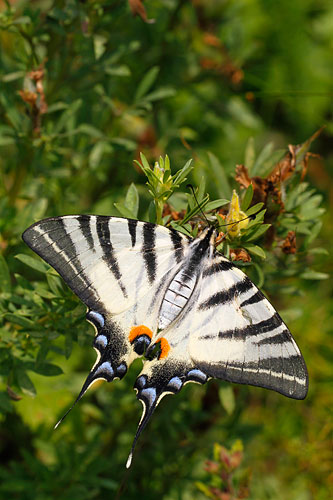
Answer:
top-left (23, 215), bottom-right (189, 414)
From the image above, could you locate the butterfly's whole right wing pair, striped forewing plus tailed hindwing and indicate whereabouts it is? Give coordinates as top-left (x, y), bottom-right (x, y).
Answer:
top-left (127, 230), bottom-right (308, 466)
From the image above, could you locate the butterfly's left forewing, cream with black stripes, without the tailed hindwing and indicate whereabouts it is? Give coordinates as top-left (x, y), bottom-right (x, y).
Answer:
top-left (23, 215), bottom-right (187, 314)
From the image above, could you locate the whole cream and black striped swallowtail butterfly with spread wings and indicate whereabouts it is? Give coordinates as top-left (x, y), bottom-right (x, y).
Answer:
top-left (23, 215), bottom-right (308, 467)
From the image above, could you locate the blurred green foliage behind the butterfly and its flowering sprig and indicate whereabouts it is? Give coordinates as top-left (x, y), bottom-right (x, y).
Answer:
top-left (0, 0), bottom-right (333, 500)
